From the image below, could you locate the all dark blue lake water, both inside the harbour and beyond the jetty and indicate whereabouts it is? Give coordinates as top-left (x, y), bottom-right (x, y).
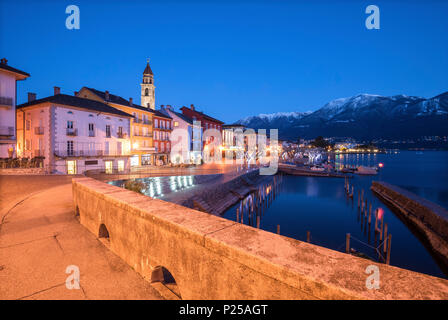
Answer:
top-left (224, 151), bottom-right (448, 278)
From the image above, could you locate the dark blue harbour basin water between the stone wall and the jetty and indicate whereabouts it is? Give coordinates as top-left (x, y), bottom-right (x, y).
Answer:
top-left (224, 171), bottom-right (446, 278)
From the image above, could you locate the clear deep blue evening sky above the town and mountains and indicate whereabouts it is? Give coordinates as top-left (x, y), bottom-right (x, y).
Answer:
top-left (0, 0), bottom-right (448, 122)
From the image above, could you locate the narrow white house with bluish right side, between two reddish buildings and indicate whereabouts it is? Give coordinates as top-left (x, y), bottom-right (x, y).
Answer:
top-left (160, 105), bottom-right (202, 164)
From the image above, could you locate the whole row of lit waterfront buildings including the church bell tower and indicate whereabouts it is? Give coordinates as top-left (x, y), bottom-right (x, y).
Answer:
top-left (0, 59), bottom-right (258, 174)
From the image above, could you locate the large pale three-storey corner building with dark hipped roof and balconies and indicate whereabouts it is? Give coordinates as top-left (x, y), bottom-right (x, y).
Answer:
top-left (17, 87), bottom-right (132, 174)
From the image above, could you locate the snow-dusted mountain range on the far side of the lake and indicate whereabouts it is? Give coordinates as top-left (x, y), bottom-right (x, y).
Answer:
top-left (237, 92), bottom-right (448, 139)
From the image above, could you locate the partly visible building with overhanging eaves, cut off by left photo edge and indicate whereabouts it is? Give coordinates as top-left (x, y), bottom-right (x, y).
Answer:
top-left (0, 58), bottom-right (30, 158)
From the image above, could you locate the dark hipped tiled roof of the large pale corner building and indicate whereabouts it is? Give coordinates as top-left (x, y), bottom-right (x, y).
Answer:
top-left (17, 94), bottom-right (131, 117)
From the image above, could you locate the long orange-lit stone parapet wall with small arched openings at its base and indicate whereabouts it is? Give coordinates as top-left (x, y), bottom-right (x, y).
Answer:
top-left (73, 178), bottom-right (448, 300)
